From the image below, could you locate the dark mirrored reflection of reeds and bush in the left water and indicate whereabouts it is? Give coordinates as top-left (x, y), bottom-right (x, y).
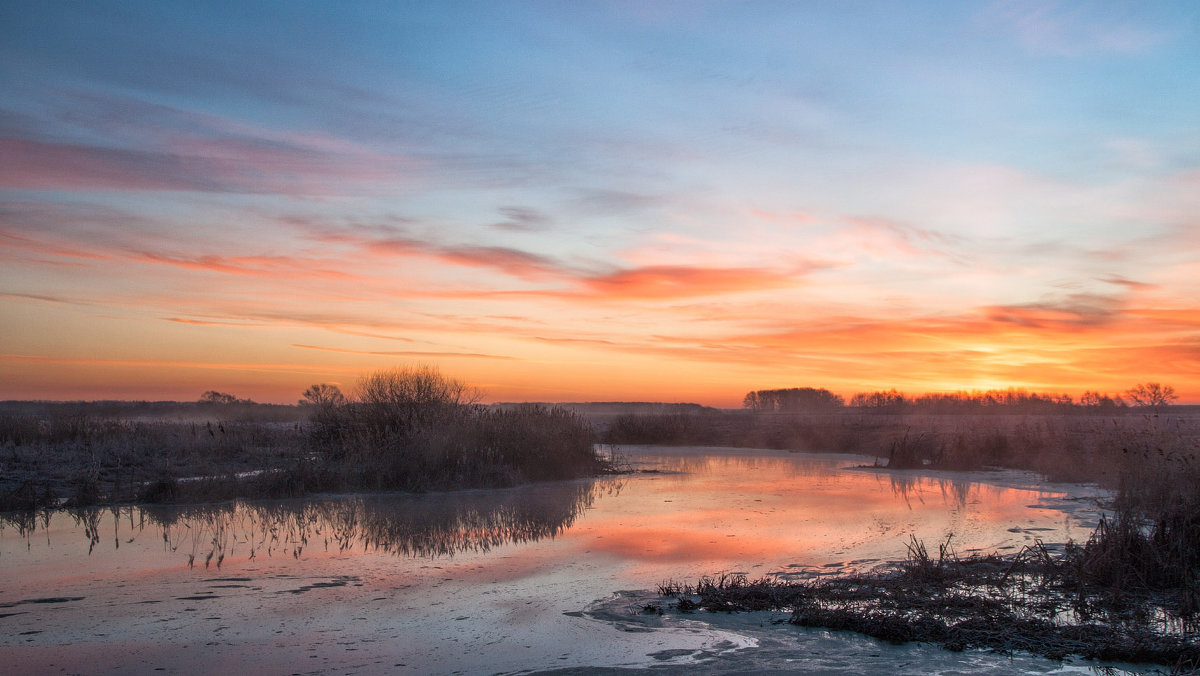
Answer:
top-left (0, 479), bottom-right (620, 568)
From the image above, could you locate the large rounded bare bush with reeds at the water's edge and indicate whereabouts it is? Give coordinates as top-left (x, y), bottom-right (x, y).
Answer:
top-left (311, 367), bottom-right (608, 490)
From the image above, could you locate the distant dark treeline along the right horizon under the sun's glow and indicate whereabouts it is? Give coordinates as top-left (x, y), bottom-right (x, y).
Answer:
top-left (743, 383), bottom-right (1177, 413)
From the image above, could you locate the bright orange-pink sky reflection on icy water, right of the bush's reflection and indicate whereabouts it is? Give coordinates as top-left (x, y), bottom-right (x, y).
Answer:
top-left (552, 449), bottom-right (1087, 578)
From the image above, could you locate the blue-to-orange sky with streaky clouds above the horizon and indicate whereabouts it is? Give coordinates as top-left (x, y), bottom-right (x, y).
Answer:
top-left (0, 0), bottom-right (1200, 407)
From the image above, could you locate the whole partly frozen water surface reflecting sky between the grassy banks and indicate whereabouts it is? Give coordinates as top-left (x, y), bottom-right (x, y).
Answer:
top-left (0, 447), bottom-right (1147, 674)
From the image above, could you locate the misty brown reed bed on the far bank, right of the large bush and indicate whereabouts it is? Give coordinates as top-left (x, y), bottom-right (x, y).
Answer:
top-left (601, 412), bottom-right (1200, 489)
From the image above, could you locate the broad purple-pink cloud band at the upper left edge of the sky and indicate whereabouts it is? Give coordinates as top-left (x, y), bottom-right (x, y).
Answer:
top-left (0, 91), bottom-right (421, 196)
